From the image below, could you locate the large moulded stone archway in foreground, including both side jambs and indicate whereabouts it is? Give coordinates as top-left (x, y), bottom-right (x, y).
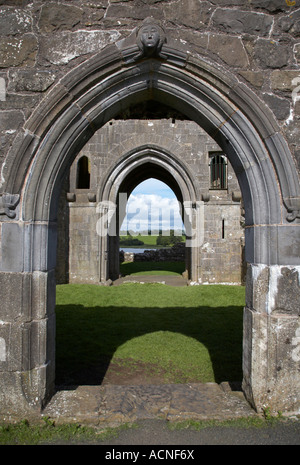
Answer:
top-left (0, 27), bottom-right (300, 416)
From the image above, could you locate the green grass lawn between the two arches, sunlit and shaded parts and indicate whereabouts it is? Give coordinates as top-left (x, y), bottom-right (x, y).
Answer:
top-left (56, 284), bottom-right (245, 384)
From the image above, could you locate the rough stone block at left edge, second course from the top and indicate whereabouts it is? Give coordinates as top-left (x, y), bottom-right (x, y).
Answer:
top-left (0, 34), bottom-right (38, 68)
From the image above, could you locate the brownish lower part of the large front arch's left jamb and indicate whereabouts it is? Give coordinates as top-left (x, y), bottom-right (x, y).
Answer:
top-left (0, 271), bottom-right (55, 419)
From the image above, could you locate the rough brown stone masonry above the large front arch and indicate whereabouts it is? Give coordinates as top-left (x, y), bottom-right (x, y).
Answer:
top-left (0, 0), bottom-right (300, 181)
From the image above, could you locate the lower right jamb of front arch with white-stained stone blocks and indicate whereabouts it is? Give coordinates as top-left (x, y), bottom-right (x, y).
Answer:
top-left (243, 264), bottom-right (300, 414)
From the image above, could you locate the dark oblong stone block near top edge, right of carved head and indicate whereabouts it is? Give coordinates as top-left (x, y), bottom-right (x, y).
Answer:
top-left (212, 8), bottom-right (273, 36)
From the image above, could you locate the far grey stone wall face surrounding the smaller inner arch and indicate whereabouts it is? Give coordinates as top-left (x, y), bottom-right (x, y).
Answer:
top-left (57, 119), bottom-right (244, 283)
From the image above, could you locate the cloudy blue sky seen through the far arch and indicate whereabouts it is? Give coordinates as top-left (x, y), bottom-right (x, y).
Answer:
top-left (121, 178), bottom-right (182, 232)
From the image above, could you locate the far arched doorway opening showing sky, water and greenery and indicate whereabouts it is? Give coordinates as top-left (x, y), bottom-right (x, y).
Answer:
top-left (119, 178), bottom-right (186, 276)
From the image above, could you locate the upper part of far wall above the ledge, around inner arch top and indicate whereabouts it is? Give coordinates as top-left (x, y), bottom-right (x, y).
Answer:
top-left (70, 119), bottom-right (239, 195)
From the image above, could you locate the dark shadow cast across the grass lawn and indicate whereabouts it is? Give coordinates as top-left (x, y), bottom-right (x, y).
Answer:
top-left (56, 305), bottom-right (243, 389)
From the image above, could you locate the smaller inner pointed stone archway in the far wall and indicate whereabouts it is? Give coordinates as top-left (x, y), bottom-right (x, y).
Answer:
top-left (97, 144), bottom-right (200, 283)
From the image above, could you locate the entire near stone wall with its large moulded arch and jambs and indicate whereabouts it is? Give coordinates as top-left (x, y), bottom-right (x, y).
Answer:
top-left (0, 0), bottom-right (300, 419)
